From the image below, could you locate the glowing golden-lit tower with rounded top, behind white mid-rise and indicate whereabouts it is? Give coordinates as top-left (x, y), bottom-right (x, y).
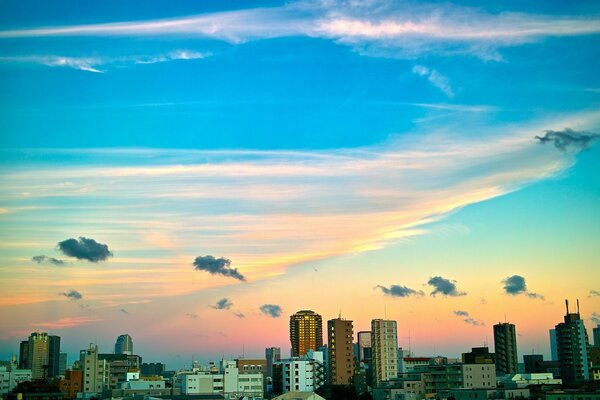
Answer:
top-left (290, 310), bottom-right (323, 357)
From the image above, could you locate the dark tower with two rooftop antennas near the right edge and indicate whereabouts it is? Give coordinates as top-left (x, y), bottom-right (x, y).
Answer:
top-left (555, 300), bottom-right (590, 386)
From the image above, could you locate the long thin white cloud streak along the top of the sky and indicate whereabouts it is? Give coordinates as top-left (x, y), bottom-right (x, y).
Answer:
top-left (0, 1), bottom-right (600, 60)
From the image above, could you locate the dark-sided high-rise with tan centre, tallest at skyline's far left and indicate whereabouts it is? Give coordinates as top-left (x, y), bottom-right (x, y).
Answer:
top-left (19, 332), bottom-right (60, 379)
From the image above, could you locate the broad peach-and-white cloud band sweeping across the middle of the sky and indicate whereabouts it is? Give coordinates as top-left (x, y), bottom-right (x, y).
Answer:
top-left (0, 113), bottom-right (600, 298)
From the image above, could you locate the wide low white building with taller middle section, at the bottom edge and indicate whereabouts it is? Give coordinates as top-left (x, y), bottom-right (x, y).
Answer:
top-left (177, 360), bottom-right (263, 399)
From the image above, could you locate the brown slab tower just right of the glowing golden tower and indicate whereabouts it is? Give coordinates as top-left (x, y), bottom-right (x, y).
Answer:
top-left (327, 317), bottom-right (354, 385)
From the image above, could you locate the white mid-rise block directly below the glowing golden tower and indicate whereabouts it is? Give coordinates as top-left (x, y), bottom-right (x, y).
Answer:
top-left (277, 351), bottom-right (325, 393)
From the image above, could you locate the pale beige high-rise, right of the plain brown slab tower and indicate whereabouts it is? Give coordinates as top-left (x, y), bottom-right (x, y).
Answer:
top-left (371, 319), bottom-right (398, 386)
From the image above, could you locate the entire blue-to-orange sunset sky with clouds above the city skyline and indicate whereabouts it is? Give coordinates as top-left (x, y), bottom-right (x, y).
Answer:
top-left (0, 0), bottom-right (600, 368)
